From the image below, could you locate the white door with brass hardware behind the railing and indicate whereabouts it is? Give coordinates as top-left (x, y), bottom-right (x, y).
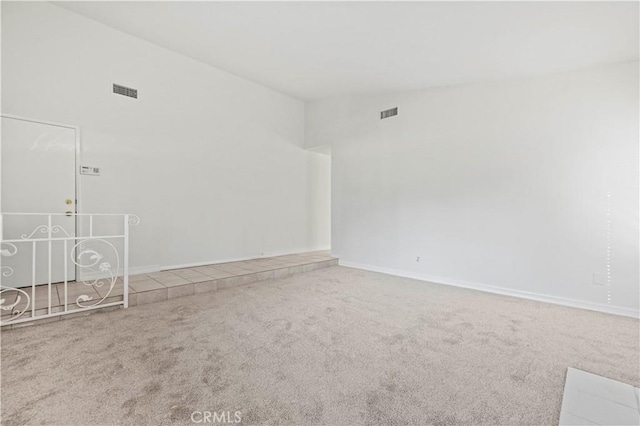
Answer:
top-left (0, 116), bottom-right (76, 287)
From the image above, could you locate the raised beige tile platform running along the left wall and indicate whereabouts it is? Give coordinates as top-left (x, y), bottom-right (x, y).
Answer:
top-left (1, 250), bottom-right (338, 330)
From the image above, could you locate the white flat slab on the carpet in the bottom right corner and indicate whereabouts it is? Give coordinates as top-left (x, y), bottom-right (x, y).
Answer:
top-left (560, 368), bottom-right (640, 426)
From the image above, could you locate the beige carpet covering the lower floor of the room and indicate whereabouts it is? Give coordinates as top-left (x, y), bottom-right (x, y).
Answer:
top-left (1, 267), bottom-right (640, 426)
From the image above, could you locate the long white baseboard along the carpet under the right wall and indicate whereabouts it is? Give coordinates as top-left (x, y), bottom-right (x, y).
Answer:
top-left (339, 260), bottom-right (640, 319)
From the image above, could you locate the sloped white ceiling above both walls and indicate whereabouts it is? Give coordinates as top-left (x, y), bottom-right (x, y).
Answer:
top-left (56, 2), bottom-right (639, 100)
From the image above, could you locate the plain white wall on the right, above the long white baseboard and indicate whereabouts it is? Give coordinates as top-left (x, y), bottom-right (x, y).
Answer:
top-left (306, 62), bottom-right (640, 315)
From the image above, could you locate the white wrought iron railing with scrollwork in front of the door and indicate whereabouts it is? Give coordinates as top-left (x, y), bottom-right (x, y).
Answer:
top-left (0, 213), bottom-right (140, 326)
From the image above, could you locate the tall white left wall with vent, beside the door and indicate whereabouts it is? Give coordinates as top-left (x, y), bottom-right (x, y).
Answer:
top-left (2, 2), bottom-right (328, 271)
